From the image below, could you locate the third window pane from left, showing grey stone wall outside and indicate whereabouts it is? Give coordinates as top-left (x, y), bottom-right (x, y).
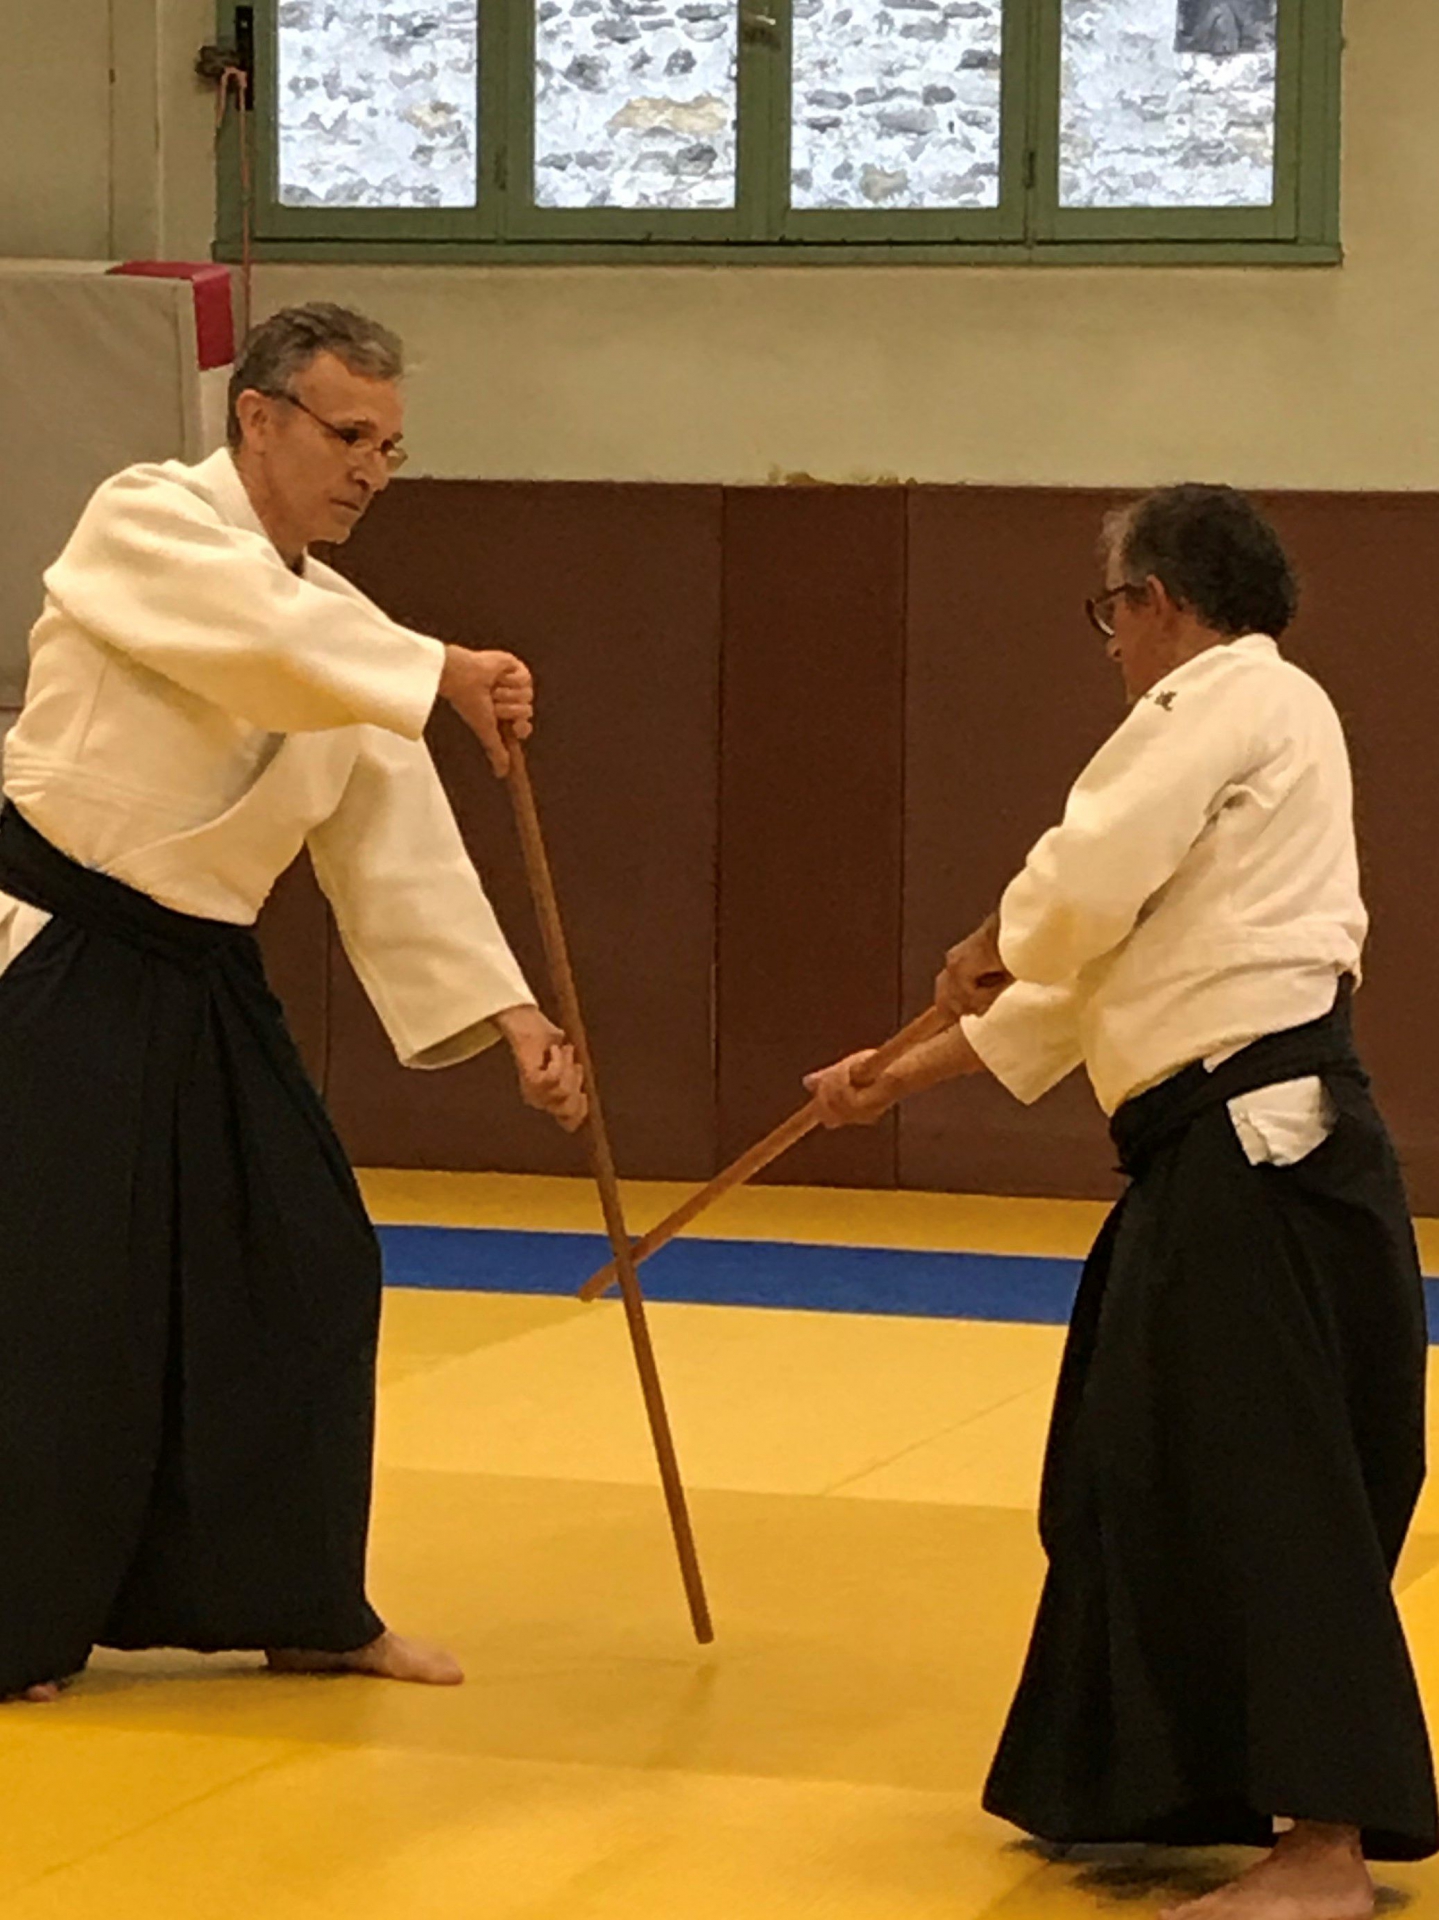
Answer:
top-left (790, 0), bottom-right (1003, 207)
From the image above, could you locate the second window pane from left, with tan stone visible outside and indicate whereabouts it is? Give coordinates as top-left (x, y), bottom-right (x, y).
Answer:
top-left (534, 0), bottom-right (740, 207)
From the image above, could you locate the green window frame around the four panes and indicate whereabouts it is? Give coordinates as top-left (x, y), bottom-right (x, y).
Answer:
top-left (215, 0), bottom-right (1343, 265)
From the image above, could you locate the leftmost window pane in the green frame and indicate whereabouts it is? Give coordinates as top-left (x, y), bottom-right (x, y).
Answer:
top-left (279, 0), bottom-right (478, 207)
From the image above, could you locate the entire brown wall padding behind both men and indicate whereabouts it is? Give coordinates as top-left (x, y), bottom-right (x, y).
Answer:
top-left (251, 480), bottom-right (1439, 1212)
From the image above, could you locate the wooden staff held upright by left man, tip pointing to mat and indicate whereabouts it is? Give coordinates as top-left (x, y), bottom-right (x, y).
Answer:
top-left (501, 726), bottom-right (715, 1645)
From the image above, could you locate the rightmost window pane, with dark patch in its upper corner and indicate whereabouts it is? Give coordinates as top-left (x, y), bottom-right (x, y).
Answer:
top-left (1059, 0), bottom-right (1276, 207)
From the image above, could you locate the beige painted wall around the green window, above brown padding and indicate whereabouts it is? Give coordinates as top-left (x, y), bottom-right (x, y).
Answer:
top-left (11, 0), bottom-right (1439, 488)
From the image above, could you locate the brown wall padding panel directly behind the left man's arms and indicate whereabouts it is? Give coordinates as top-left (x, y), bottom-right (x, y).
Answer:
top-left (315, 482), bottom-right (720, 1177)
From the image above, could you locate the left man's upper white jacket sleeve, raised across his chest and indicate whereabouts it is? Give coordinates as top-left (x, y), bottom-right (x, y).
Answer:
top-left (46, 467), bottom-right (444, 739)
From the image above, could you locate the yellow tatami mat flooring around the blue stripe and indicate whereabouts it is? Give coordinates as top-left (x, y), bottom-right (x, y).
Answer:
top-left (0, 1175), bottom-right (1439, 1920)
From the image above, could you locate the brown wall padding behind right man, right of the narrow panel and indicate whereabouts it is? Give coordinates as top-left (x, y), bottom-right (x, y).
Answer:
top-left (899, 488), bottom-right (1439, 1212)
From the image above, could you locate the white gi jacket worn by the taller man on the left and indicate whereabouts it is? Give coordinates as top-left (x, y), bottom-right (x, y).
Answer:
top-left (0, 451), bottom-right (534, 1068)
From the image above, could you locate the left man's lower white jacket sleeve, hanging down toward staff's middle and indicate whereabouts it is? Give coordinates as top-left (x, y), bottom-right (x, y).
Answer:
top-left (309, 728), bottom-right (534, 1068)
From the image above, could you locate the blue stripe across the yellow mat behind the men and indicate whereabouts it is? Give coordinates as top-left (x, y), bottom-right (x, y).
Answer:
top-left (380, 1227), bottom-right (1439, 1344)
